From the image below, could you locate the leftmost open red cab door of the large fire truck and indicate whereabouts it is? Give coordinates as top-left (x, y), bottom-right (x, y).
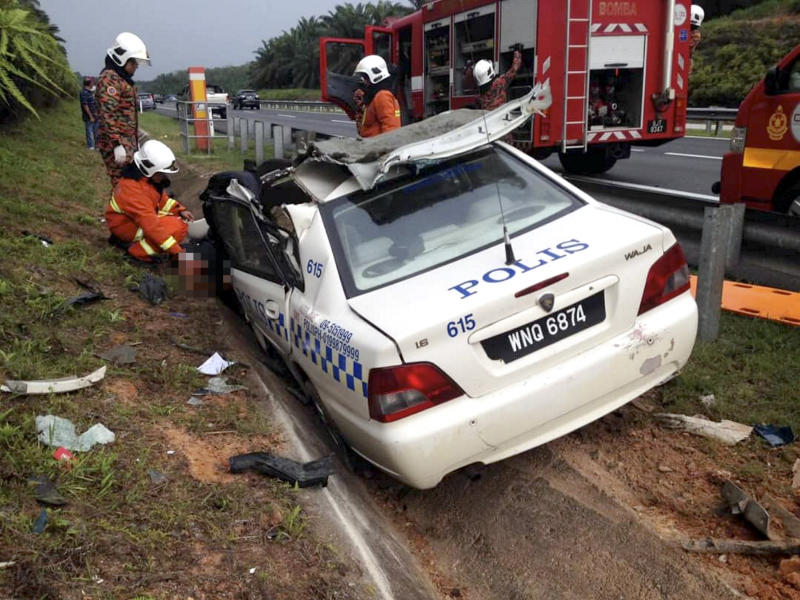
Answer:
top-left (319, 37), bottom-right (366, 119)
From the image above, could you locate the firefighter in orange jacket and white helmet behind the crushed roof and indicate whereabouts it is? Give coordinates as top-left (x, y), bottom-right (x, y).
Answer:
top-left (353, 54), bottom-right (401, 138)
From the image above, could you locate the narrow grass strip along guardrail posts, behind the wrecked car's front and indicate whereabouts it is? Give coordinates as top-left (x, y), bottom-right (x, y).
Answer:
top-left (139, 112), bottom-right (272, 172)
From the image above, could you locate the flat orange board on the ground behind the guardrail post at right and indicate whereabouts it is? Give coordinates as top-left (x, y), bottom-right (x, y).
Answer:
top-left (691, 275), bottom-right (800, 326)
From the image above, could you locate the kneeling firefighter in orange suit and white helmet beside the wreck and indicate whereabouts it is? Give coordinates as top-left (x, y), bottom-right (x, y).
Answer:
top-left (105, 140), bottom-right (194, 262)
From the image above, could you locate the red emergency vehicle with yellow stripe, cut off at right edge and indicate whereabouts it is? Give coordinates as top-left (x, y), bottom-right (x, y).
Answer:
top-left (719, 46), bottom-right (800, 216)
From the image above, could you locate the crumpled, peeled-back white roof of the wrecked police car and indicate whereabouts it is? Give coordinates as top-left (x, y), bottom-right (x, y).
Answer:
top-left (295, 81), bottom-right (552, 190)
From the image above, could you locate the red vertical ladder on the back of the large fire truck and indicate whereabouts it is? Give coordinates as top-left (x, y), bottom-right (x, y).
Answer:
top-left (561, 0), bottom-right (592, 152)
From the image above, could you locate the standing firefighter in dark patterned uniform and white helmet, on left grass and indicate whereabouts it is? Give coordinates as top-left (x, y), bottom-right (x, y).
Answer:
top-left (95, 32), bottom-right (150, 187)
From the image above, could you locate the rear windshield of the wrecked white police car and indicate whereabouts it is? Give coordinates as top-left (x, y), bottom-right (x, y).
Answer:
top-left (323, 148), bottom-right (581, 296)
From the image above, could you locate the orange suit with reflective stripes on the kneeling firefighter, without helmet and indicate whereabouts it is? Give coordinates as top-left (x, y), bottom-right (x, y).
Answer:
top-left (105, 171), bottom-right (188, 262)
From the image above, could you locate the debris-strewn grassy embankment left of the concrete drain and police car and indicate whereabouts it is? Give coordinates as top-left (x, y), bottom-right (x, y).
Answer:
top-left (0, 103), bottom-right (356, 600)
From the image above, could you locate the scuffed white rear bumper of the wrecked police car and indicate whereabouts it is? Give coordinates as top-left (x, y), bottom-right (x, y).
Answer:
top-left (332, 292), bottom-right (697, 489)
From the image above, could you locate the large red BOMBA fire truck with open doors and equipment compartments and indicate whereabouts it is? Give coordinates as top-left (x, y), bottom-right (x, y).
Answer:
top-left (320, 0), bottom-right (690, 173)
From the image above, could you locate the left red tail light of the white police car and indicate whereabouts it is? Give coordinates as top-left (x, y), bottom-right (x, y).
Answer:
top-left (368, 363), bottom-right (464, 423)
